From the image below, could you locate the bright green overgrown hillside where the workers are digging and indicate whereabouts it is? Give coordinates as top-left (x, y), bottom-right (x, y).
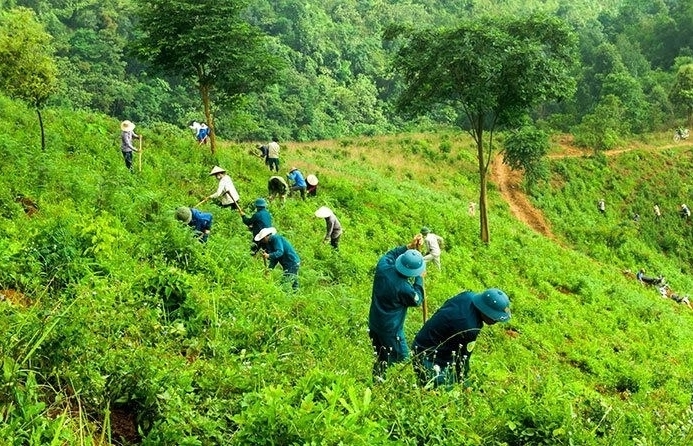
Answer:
top-left (0, 99), bottom-right (693, 444)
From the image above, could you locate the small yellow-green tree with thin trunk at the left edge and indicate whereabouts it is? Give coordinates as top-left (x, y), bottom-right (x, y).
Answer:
top-left (0, 8), bottom-right (58, 150)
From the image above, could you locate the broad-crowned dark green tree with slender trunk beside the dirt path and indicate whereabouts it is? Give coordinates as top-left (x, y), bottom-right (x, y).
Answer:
top-left (386, 15), bottom-right (577, 243)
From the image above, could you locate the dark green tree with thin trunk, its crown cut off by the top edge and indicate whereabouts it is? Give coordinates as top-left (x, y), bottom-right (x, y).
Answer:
top-left (135, 0), bottom-right (282, 153)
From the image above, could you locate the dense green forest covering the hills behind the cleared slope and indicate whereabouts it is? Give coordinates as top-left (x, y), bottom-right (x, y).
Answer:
top-left (0, 0), bottom-right (693, 141)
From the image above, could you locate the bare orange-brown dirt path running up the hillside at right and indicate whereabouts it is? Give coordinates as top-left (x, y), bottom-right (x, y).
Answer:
top-left (490, 138), bottom-right (681, 240)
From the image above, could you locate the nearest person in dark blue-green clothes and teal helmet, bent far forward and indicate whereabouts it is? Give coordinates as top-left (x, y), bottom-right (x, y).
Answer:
top-left (412, 288), bottom-right (510, 387)
